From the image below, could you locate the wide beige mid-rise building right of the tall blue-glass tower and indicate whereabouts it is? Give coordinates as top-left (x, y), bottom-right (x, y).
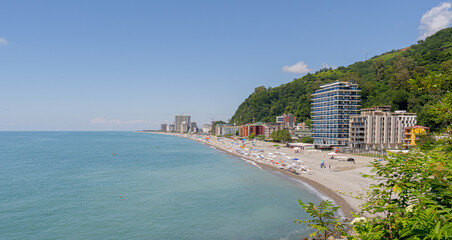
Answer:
top-left (349, 106), bottom-right (416, 150)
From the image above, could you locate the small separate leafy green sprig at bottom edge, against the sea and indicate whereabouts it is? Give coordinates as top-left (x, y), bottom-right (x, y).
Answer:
top-left (294, 200), bottom-right (342, 239)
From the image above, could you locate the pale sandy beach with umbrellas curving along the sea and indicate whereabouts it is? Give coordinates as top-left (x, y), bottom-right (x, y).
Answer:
top-left (150, 133), bottom-right (374, 219)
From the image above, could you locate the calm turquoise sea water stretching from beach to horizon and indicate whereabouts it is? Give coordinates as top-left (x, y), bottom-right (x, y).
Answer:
top-left (0, 132), bottom-right (320, 239)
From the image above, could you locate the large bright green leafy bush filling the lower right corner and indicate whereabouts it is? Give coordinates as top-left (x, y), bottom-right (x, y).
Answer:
top-left (354, 138), bottom-right (452, 239)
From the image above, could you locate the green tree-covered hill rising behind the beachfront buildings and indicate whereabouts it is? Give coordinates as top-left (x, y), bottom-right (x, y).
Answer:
top-left (231, 28), bottom-right (452, 130)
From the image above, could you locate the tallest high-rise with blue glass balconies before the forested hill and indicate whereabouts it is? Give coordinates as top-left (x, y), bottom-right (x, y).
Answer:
top-left (311, 81), bottom-right (360, 147)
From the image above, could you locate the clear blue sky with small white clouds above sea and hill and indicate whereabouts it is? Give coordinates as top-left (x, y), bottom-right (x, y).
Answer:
top-left (0, 0), bottom-right (452, 131)
